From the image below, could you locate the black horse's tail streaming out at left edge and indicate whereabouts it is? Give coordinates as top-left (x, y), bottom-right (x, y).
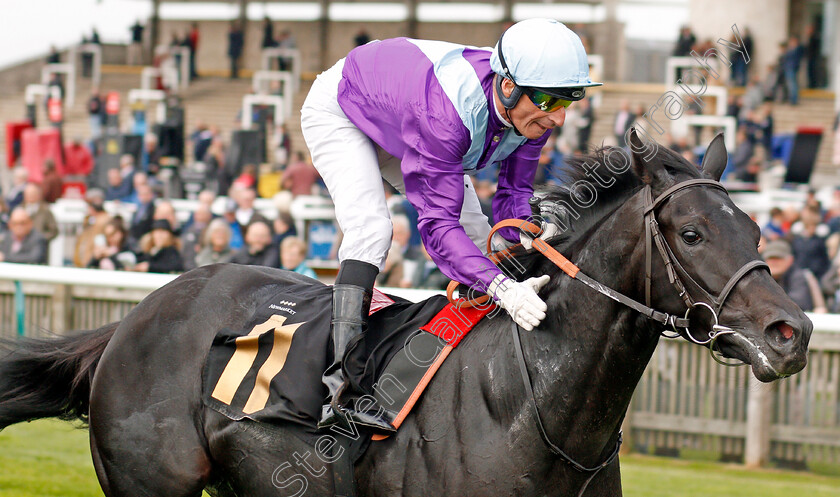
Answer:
top-left (0, 323), bottom-right (119, 430)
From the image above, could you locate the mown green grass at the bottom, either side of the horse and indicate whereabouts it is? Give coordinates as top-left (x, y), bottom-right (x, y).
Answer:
top-left (0, 420), bottom-right (840, 497)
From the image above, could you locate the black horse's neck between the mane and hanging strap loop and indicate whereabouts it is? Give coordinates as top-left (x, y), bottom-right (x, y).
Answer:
top-left (522, 193), bottom-right (658, 465)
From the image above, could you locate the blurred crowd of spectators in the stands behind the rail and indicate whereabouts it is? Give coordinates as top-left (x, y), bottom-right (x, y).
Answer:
top-left (0, 19), bottom-right (840, 302)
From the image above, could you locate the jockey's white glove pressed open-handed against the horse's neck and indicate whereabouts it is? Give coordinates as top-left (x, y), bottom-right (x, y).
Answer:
top-left (487, 274), bottom-right (549, 331)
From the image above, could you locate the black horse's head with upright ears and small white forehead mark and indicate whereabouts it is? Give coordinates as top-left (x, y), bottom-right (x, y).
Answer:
top-left (630, 131), bottom-right (813, 382)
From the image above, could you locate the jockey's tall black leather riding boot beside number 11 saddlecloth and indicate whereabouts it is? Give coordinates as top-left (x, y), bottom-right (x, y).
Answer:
top-left (318, 261), bottom-right (396, 432)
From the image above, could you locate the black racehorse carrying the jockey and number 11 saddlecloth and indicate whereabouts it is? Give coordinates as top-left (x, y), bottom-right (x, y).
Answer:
top-left (0, 135), bottom-right (812, 497)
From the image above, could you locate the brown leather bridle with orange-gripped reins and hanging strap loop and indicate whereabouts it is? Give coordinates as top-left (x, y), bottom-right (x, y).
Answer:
top-left (447, 179), bottom-right (770, 495)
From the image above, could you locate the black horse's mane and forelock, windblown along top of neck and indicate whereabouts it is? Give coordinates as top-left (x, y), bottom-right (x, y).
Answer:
top-left (502, 145), bottom-right (701, 277)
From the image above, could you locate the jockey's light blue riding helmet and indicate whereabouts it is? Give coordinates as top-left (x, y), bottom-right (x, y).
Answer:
top-left (490, 18), bottom-right (603, 107)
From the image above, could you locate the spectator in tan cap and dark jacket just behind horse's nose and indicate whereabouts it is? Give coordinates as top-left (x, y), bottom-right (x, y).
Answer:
top-left (761, 240), bottom-right (825, 312)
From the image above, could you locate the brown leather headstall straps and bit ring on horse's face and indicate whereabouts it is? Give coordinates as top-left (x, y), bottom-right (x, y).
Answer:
top-left (644, 179), bottom-right (770, 356)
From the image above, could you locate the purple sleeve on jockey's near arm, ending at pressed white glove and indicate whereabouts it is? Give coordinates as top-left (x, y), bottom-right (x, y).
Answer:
top-left (402, 145), bottom-right (501, 288)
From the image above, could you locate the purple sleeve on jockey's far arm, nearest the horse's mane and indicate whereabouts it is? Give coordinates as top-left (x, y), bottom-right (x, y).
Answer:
top-left (493, 131), bottom-right (551, 241)
